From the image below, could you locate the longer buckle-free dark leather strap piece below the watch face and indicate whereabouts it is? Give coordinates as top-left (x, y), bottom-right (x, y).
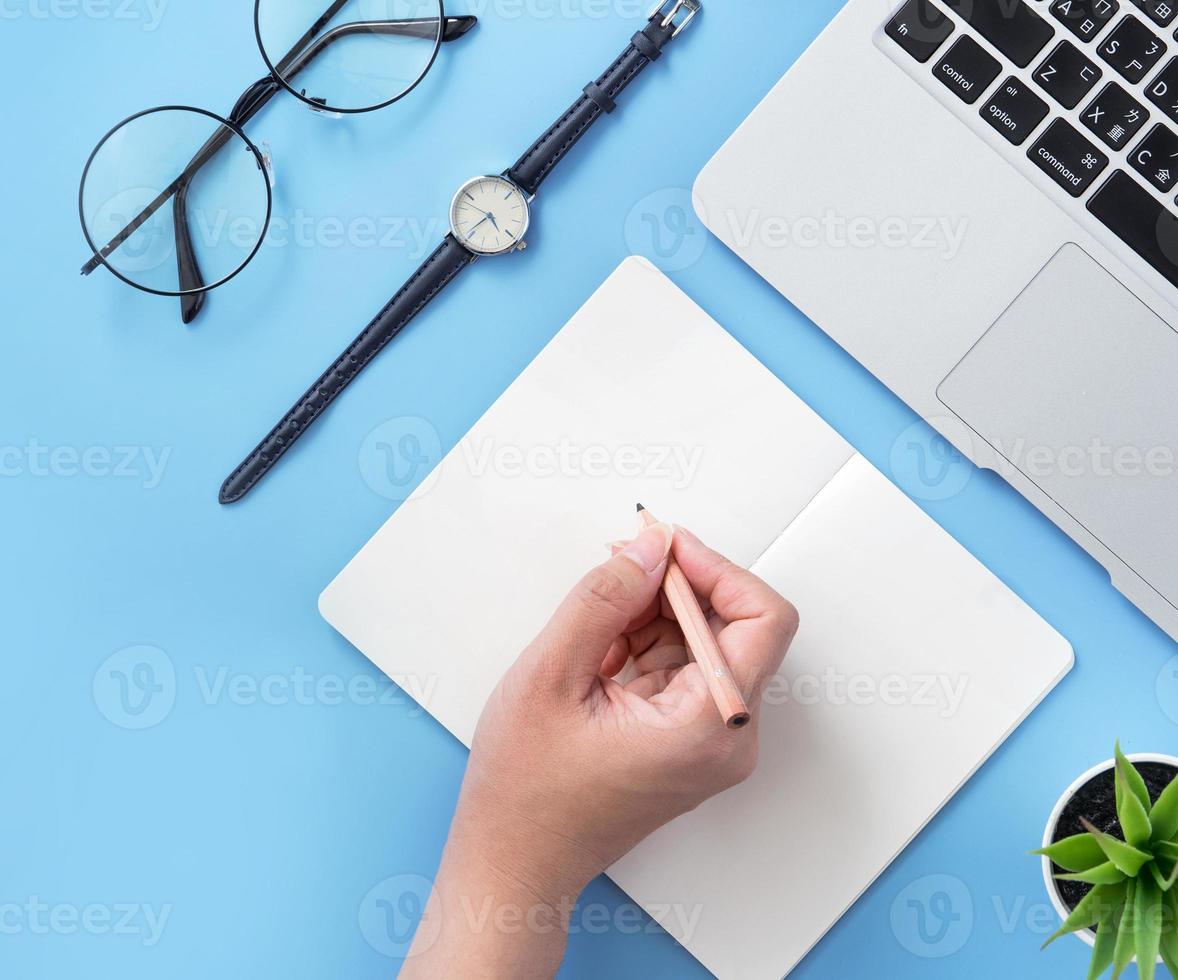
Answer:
top-left (220, 234), bottom-right (475, 504)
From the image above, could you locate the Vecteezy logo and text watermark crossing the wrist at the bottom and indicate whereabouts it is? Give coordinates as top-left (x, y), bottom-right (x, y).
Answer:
top-left (359, 874), bottom-right (703, 959)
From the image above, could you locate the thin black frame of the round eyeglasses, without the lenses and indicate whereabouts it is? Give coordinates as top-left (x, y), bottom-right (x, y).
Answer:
top-left (78, 0), bottom-right (478, 324)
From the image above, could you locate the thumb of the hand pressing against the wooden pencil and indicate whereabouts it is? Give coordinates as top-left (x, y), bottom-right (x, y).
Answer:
top-left (529, 524), bottom-right (675, 695)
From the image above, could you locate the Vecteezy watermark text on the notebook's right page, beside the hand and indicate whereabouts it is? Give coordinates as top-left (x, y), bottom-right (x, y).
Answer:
top-left (761, 666), bottom-right (969, 719)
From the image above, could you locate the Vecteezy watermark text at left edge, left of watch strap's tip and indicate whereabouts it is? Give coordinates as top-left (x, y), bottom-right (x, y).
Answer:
top-left (0, 438), bottom-right (172, 490)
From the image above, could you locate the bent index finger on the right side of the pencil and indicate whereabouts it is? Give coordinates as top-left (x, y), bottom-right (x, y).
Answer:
top-left (674, 528), bottom-right (798, 711)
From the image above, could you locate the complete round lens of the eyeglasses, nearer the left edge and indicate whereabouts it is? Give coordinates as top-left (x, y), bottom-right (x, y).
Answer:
top-left (79, 106), bottom-right (271, 296)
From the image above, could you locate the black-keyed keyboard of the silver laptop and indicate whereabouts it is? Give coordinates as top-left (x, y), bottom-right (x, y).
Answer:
top-left (884, 0), bottom-right (1178, 286)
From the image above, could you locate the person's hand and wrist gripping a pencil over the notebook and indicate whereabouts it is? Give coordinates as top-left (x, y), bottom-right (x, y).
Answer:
top-left (405, 524), bottom-right (798, 975)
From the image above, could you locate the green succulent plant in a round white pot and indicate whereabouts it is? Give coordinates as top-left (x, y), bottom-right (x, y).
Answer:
top-left (1032, 743), bottom-right (1178, 980)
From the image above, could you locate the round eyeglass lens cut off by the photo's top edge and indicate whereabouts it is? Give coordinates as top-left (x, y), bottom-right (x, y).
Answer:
top-left (253, 0), bottom-right (443, 112)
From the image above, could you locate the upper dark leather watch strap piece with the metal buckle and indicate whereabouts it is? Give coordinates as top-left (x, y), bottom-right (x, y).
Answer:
top-left (507, 0), bottom-right (700, 194)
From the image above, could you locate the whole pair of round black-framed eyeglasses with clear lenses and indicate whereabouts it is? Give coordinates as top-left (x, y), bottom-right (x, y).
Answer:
top-left (78, 0), bottom-right (477, 324)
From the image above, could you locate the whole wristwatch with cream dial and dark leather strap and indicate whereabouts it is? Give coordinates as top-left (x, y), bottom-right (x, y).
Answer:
top-left (220, 0), bottom-right (700, 504)
